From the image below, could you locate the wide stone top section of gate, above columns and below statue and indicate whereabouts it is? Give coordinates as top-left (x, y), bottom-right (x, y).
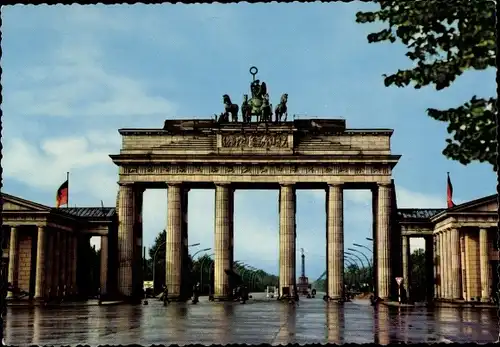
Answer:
top-left (110, 119), bottom-right (400, 188)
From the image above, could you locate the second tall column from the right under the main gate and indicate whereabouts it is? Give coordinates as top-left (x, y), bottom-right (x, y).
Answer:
top-left (326, 184), bottom-right (344, 300)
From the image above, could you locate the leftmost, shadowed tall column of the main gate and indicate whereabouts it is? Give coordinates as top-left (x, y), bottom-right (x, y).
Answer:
top-left (118, 184), bottom-right (135, 297)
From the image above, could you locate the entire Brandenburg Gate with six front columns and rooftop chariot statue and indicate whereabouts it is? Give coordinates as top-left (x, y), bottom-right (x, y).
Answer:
top-left (110, 68), bottom-right (400, 300)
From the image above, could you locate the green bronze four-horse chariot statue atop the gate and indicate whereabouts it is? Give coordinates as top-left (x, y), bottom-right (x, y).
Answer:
top-left (215, 66), bottom-right (288, 123)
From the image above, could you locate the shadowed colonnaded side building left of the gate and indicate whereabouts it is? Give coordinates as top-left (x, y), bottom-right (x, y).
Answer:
top-left (2, 193), bottom-right (118, 300)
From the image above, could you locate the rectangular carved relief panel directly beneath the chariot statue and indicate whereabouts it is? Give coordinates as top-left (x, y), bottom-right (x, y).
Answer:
top-left (222, 134), bottom-right (288, 148)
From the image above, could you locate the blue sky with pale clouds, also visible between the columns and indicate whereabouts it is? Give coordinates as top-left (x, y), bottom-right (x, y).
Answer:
top-left (1, 2), bottom-right (496, 278)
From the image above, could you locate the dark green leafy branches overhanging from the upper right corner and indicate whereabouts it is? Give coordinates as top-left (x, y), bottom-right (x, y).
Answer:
top-left (356, 0), bottom-right (497, 171)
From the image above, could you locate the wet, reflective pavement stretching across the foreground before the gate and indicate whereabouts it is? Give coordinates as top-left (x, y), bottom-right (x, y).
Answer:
top-left (5, 294), bottom-right (499, 345)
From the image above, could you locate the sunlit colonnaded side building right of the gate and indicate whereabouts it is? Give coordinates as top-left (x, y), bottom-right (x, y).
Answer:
top-left (398, 194), bottom-right (499, 302)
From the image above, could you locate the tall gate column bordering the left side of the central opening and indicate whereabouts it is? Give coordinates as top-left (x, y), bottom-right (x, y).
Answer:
top-left (214, 184), bottom-right (234, 300)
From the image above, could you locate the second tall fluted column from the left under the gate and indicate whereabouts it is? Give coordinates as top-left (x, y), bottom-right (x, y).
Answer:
top-left (165, 184), bottom-right (183, 300)
